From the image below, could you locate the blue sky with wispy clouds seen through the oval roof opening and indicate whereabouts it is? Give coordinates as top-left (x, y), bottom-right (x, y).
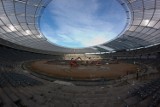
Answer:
top-left (40, 0), bottom-right (127, 48)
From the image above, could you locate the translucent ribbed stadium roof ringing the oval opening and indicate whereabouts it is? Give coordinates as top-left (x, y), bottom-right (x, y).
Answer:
top-left (0, 0), bottom-right (160, 53)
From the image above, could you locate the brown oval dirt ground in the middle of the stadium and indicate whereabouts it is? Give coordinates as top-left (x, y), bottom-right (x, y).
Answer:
top-left (31, 61), bottom-right (138, 79)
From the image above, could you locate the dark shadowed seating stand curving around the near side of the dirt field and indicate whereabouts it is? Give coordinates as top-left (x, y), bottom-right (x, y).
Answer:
top-left (0, 43), bottom-right (160, 107)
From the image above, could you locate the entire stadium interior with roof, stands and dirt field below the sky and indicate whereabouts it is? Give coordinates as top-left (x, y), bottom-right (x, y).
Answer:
top-left (0, 0), bottom-right (160, 107)
